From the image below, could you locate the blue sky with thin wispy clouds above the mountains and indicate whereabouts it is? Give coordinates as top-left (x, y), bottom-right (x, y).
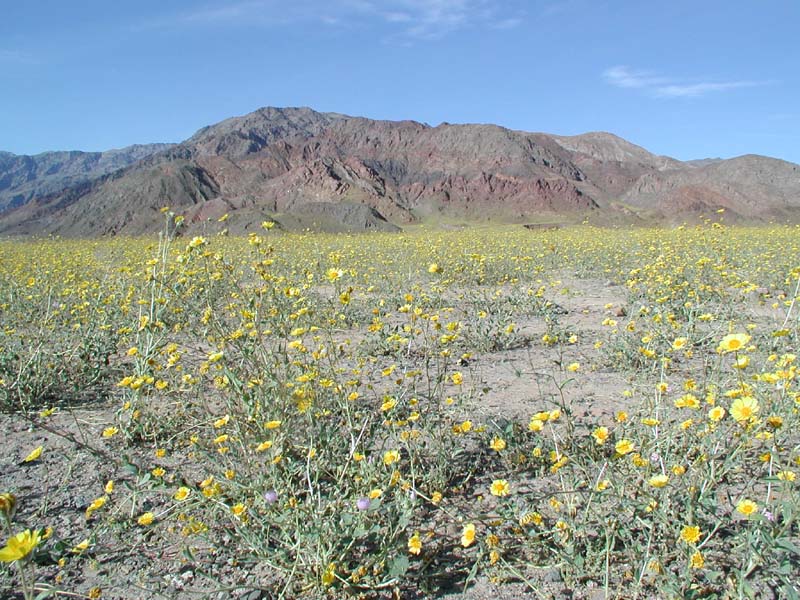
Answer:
top-left (0, 0), bottom-right (800, 163)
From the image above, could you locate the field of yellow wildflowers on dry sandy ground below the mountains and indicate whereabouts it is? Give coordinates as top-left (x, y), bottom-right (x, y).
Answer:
top-left (0, 214), bottom-right (800, 599)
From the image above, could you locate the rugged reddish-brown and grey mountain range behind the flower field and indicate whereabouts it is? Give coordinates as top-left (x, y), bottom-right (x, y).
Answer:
top-left (0, 108), bottom-right (800, 236)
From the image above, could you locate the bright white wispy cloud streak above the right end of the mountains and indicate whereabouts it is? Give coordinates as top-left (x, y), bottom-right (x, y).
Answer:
top-left (603, 65), bottom-right (771, 98)
